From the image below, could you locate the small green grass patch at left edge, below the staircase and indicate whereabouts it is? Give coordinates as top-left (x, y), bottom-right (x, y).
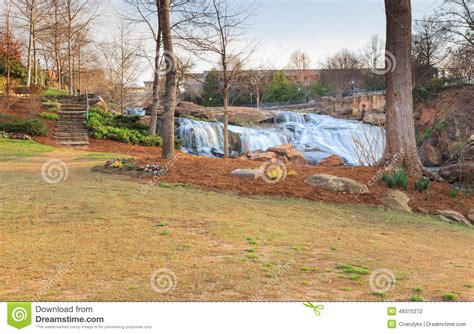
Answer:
top-left (0, 139), bottom-right (53, 161)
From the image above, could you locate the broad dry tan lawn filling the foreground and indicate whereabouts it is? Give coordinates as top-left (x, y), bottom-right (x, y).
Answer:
top-left (0, 142), bottom-right (474, 301)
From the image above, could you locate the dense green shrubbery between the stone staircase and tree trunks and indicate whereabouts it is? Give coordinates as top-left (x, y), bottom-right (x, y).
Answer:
top-left (89, 108), bottom-right (162, 146)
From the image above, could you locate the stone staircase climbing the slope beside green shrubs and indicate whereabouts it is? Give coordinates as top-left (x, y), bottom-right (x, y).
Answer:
top-left (54, 99), bottom-right (89, 147)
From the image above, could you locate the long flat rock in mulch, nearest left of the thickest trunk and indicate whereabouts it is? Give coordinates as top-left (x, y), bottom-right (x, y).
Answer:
top-left (305, 174), bottom-right (369, 194)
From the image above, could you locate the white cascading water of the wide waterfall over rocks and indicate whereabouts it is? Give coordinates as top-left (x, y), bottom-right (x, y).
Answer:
top-left (177, 112), bottom-right (385, 166)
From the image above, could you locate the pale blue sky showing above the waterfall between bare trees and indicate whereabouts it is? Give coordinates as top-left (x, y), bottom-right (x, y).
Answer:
top-left (109, 0), bottom-right (442, 80)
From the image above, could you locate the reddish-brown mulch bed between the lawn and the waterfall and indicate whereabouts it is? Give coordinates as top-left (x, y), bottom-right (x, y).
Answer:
top-left (83, 139), bottom-right (474, 215)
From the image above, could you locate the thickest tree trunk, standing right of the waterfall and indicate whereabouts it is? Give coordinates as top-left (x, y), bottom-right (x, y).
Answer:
top-left (383, 0), bottom-right (422, 178)
